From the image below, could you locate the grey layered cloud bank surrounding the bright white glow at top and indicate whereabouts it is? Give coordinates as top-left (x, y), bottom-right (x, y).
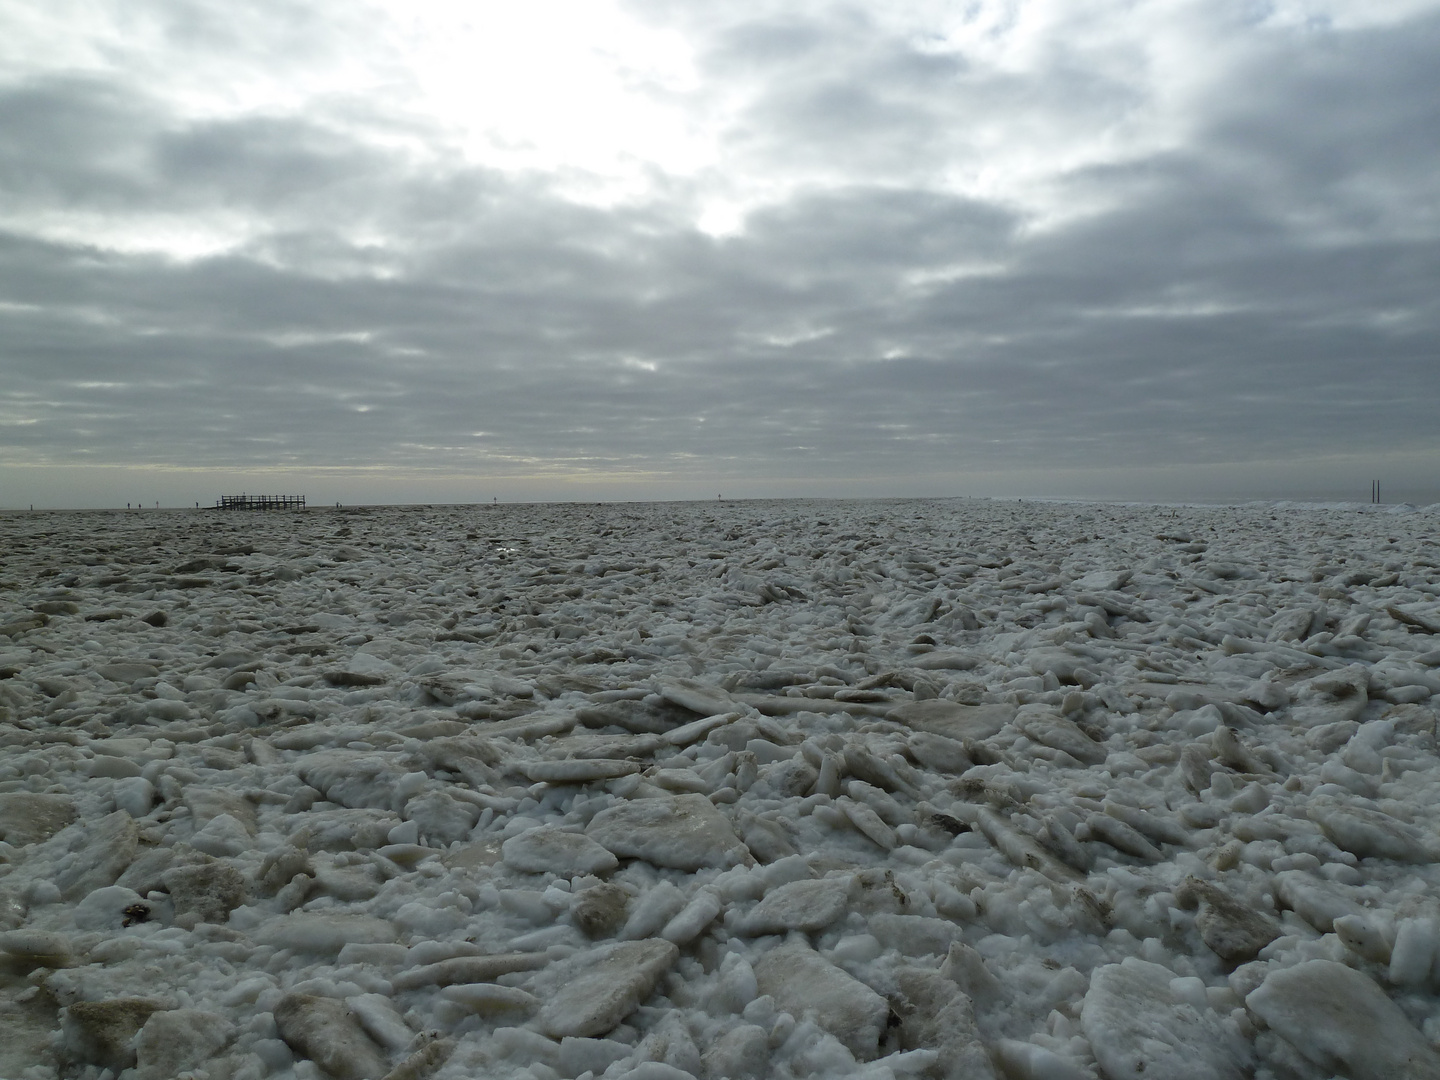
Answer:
top-left (0, 0), bottom-right (1440, 501)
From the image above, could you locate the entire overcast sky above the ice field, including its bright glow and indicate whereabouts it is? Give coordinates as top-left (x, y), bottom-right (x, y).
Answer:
top-left (0, 0), bottom-right (1440, 507)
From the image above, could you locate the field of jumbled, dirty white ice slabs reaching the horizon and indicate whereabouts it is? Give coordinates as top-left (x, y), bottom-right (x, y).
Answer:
top-left (0, 501), bottom-right (1440, 1080)
